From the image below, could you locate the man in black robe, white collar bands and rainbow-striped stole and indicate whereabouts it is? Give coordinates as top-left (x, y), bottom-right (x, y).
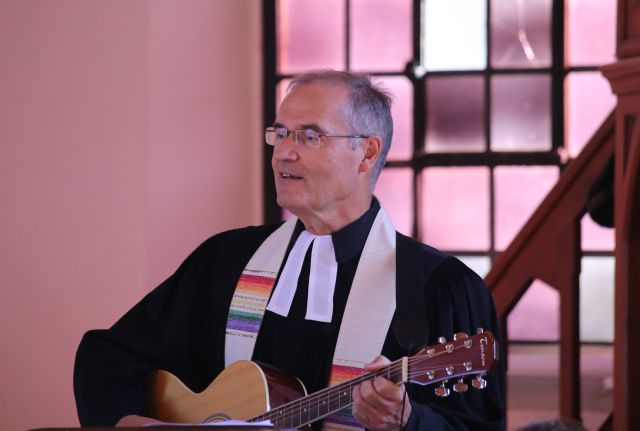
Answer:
top-left (74, 71), bottom-right (504, 430)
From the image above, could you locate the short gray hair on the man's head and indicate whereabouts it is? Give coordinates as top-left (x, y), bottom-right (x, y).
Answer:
top-left (287, 70), bottom-right (393, 185)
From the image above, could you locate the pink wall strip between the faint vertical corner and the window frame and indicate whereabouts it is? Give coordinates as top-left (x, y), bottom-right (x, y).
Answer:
top-left (146, 0), bottom-right (264, 285)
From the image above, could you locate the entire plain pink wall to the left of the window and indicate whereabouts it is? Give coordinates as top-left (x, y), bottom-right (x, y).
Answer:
top-left (0, 0), bottom-right (262, 429)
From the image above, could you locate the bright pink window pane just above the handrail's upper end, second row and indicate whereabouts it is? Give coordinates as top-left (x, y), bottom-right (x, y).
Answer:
top-left (565, 72), bottom-right (616, 157)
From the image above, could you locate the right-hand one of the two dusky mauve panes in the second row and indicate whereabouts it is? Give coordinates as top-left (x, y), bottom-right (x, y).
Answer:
top-left (491, 75), bottom-right (551, 151)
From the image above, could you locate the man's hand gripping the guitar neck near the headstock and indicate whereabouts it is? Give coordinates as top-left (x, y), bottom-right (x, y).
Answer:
top-left (352, 356), bottom-right (411, 431)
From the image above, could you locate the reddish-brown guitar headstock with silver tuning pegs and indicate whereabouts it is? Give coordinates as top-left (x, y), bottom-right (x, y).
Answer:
top-left (408, 329), bottom-right (498, 397)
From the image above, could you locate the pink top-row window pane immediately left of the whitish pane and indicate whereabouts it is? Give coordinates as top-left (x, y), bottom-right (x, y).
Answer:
top-left (350, 0), bottom-right (412, 71)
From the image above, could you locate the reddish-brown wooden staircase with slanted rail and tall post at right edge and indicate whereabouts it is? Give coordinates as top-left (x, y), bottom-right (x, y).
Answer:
top-left (485, 0), bottom-right (640, 431)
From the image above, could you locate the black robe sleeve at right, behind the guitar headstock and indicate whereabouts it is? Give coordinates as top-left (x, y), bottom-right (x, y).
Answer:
top-left (406, 257), bottom-right (505, 431)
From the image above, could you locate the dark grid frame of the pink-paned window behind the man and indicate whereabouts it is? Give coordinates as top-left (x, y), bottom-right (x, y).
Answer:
top-left (263, 0), bottom-right (611, 262)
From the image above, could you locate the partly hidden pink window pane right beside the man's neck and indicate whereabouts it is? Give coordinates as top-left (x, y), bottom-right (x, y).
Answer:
top-left (375, 168), bottom-right (413, 236)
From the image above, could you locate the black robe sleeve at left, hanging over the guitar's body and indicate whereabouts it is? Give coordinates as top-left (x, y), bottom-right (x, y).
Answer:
top-left (73, 230), bottom-right (268, 426)
